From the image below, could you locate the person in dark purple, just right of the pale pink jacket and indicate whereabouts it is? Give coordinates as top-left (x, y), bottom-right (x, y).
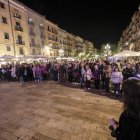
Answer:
top-left (92, 64), bottom-right (100, 90)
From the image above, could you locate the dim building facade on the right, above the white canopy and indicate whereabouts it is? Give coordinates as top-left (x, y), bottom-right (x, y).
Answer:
top-left (118, 7), bottom-right (140, 51)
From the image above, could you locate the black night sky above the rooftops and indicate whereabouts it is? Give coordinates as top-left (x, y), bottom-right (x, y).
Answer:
top-left (19, 0), bottom-right (140, 47)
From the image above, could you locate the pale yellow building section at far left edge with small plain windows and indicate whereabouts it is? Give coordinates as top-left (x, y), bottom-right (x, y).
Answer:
top-left (0, 0), bottom-right (15, 56)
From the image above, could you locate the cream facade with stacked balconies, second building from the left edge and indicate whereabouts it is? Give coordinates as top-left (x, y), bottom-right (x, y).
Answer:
top-left (9, 0), bottom-right (29, 56)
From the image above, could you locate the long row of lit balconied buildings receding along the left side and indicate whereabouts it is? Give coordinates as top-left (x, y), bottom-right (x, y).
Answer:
top-left (0, 0), bottom-right (93, 58)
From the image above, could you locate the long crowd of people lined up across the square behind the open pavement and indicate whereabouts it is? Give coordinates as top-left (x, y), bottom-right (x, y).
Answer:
top-left (0, 60), bottom-right (140, 96)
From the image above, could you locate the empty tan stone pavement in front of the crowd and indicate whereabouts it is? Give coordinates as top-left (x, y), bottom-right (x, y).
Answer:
top-left (0, 82), bottom-right (122, 140)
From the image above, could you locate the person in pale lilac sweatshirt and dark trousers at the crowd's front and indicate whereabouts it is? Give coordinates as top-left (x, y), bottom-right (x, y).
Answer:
top-left (111, 67), bottom-right (123, 97)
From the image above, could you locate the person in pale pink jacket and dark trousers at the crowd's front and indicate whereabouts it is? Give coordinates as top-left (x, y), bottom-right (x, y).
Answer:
top-left (84, 65), bottom-right (92, 90)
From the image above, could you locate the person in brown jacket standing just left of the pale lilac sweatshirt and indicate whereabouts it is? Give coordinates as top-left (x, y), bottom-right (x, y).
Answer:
top-left (103, 61), bottom-right (112, 93)
